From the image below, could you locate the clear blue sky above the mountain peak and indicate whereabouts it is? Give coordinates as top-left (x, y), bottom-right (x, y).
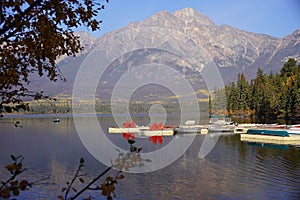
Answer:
top-left (85, 0), bottom-right (300, 38)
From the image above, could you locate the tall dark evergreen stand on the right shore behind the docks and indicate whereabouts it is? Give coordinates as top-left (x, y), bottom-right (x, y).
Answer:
top-left (210, 58), bottom-right (300, 124)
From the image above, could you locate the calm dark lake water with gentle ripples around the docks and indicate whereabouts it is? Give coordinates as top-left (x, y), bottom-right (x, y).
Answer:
top-left (0, 116), bottom-right (300, 199)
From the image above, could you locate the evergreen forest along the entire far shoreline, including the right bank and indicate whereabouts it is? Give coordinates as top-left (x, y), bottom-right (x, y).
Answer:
top-left (2, 58), bottom-right (300, 124)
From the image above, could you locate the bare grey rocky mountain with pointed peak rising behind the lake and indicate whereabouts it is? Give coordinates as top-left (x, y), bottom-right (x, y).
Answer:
top-left (28, 8), bottom-right (300, 98)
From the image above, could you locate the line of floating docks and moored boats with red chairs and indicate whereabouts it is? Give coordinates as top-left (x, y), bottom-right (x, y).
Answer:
top-left (108, 117), bottom-right (300, 145)
